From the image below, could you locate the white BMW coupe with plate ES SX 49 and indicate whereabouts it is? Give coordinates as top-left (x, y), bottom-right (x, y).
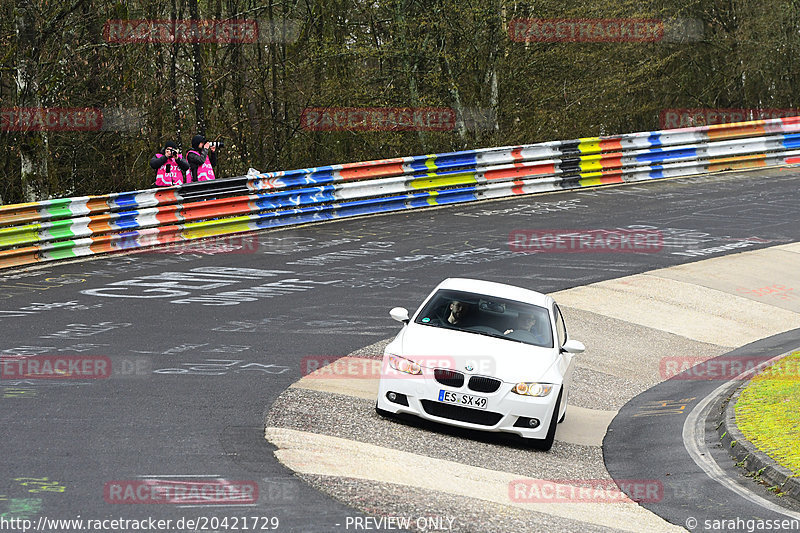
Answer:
top-left (375, 278), bottom-right (585, 450)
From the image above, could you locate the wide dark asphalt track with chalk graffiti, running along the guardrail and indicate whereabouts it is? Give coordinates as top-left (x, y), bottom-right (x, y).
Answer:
top-left (0, 169), bottom-right (800, 532)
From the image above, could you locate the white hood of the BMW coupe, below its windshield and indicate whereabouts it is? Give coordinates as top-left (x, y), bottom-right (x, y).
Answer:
top-left (387, 323), bottom-right (563, 383)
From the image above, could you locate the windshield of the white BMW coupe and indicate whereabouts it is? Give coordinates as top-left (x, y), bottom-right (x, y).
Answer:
top-left (414, 289), bottom-right (553, 348)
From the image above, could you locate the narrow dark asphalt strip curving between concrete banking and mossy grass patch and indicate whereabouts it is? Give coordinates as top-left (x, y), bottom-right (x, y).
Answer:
top-left (603, 330), bottom-right (800, 531)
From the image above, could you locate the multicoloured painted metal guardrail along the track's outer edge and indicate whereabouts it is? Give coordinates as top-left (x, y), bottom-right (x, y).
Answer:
top-left (0, 117), bottom-right (800, 268)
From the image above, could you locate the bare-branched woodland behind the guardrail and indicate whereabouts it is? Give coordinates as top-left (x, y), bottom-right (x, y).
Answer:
top-left (0, 0), bottom-right (800, 203)
